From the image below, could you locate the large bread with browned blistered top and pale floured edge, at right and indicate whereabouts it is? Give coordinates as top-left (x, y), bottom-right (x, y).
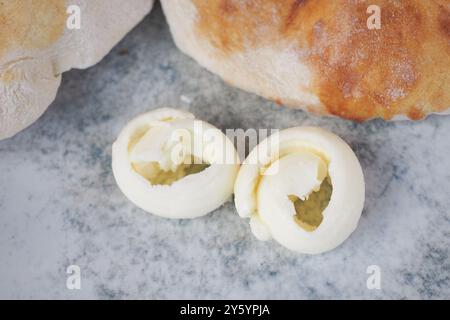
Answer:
top-left (161, 0), bottom-right (450, 121)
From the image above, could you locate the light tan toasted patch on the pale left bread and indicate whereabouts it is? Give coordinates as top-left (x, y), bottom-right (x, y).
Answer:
top-left (0, 0), bottom-right (66, 58)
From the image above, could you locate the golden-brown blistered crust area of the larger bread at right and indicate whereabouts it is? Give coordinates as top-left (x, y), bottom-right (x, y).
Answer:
top-left (193, 0), bottom-right (450, 121)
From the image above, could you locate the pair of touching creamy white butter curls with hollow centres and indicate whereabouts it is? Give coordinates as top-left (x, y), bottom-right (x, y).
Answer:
top-left (112, 108), bottom-right (365, 254)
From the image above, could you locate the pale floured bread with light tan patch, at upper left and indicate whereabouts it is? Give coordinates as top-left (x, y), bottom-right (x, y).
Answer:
top-left (0, 0), bottom-right (153, 139)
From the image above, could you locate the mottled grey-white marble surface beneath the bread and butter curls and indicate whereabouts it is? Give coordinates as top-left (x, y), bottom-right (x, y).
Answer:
top-left (0, 6), bottom-right (450, 299)
